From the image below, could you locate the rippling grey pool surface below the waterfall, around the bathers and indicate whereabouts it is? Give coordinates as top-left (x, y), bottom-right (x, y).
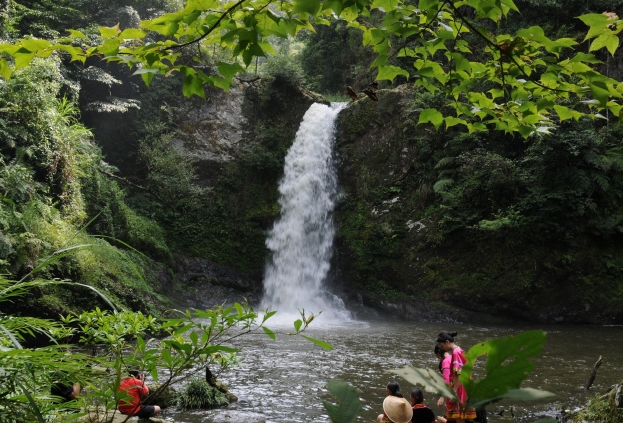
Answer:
top-left (163, 321), bottom-right (623, 423)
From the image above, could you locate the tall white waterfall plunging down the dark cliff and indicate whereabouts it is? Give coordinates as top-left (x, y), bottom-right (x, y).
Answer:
top-left (262, 103), bottom-right (348, 320)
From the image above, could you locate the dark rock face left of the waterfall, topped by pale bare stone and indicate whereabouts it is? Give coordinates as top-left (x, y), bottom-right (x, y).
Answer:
top-left (168, 78), bottom-right (324, 308)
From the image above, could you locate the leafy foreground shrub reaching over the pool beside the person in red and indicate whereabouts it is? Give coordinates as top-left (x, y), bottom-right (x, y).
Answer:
top-left (63, 303), bottom-right (330, 418)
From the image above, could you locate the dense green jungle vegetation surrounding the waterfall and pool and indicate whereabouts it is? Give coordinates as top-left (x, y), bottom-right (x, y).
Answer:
top-left (0, 0), bottom-right (623, 421)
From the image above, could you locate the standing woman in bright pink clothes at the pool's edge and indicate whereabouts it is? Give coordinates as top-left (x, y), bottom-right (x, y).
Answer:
top-left (437, 332), bottom-right (476, 423)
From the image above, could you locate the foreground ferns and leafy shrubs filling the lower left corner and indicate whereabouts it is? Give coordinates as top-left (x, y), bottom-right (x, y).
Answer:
top-left (0, 258), bottom-right (331, 423)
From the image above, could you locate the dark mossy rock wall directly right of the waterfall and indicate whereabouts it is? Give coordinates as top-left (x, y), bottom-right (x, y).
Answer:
top-left (335, 85), bottom-right (460, 320)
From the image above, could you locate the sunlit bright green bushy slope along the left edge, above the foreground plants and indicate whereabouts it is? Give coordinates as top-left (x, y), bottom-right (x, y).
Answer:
top-left (0, 54), bottom-right (170, 316)
